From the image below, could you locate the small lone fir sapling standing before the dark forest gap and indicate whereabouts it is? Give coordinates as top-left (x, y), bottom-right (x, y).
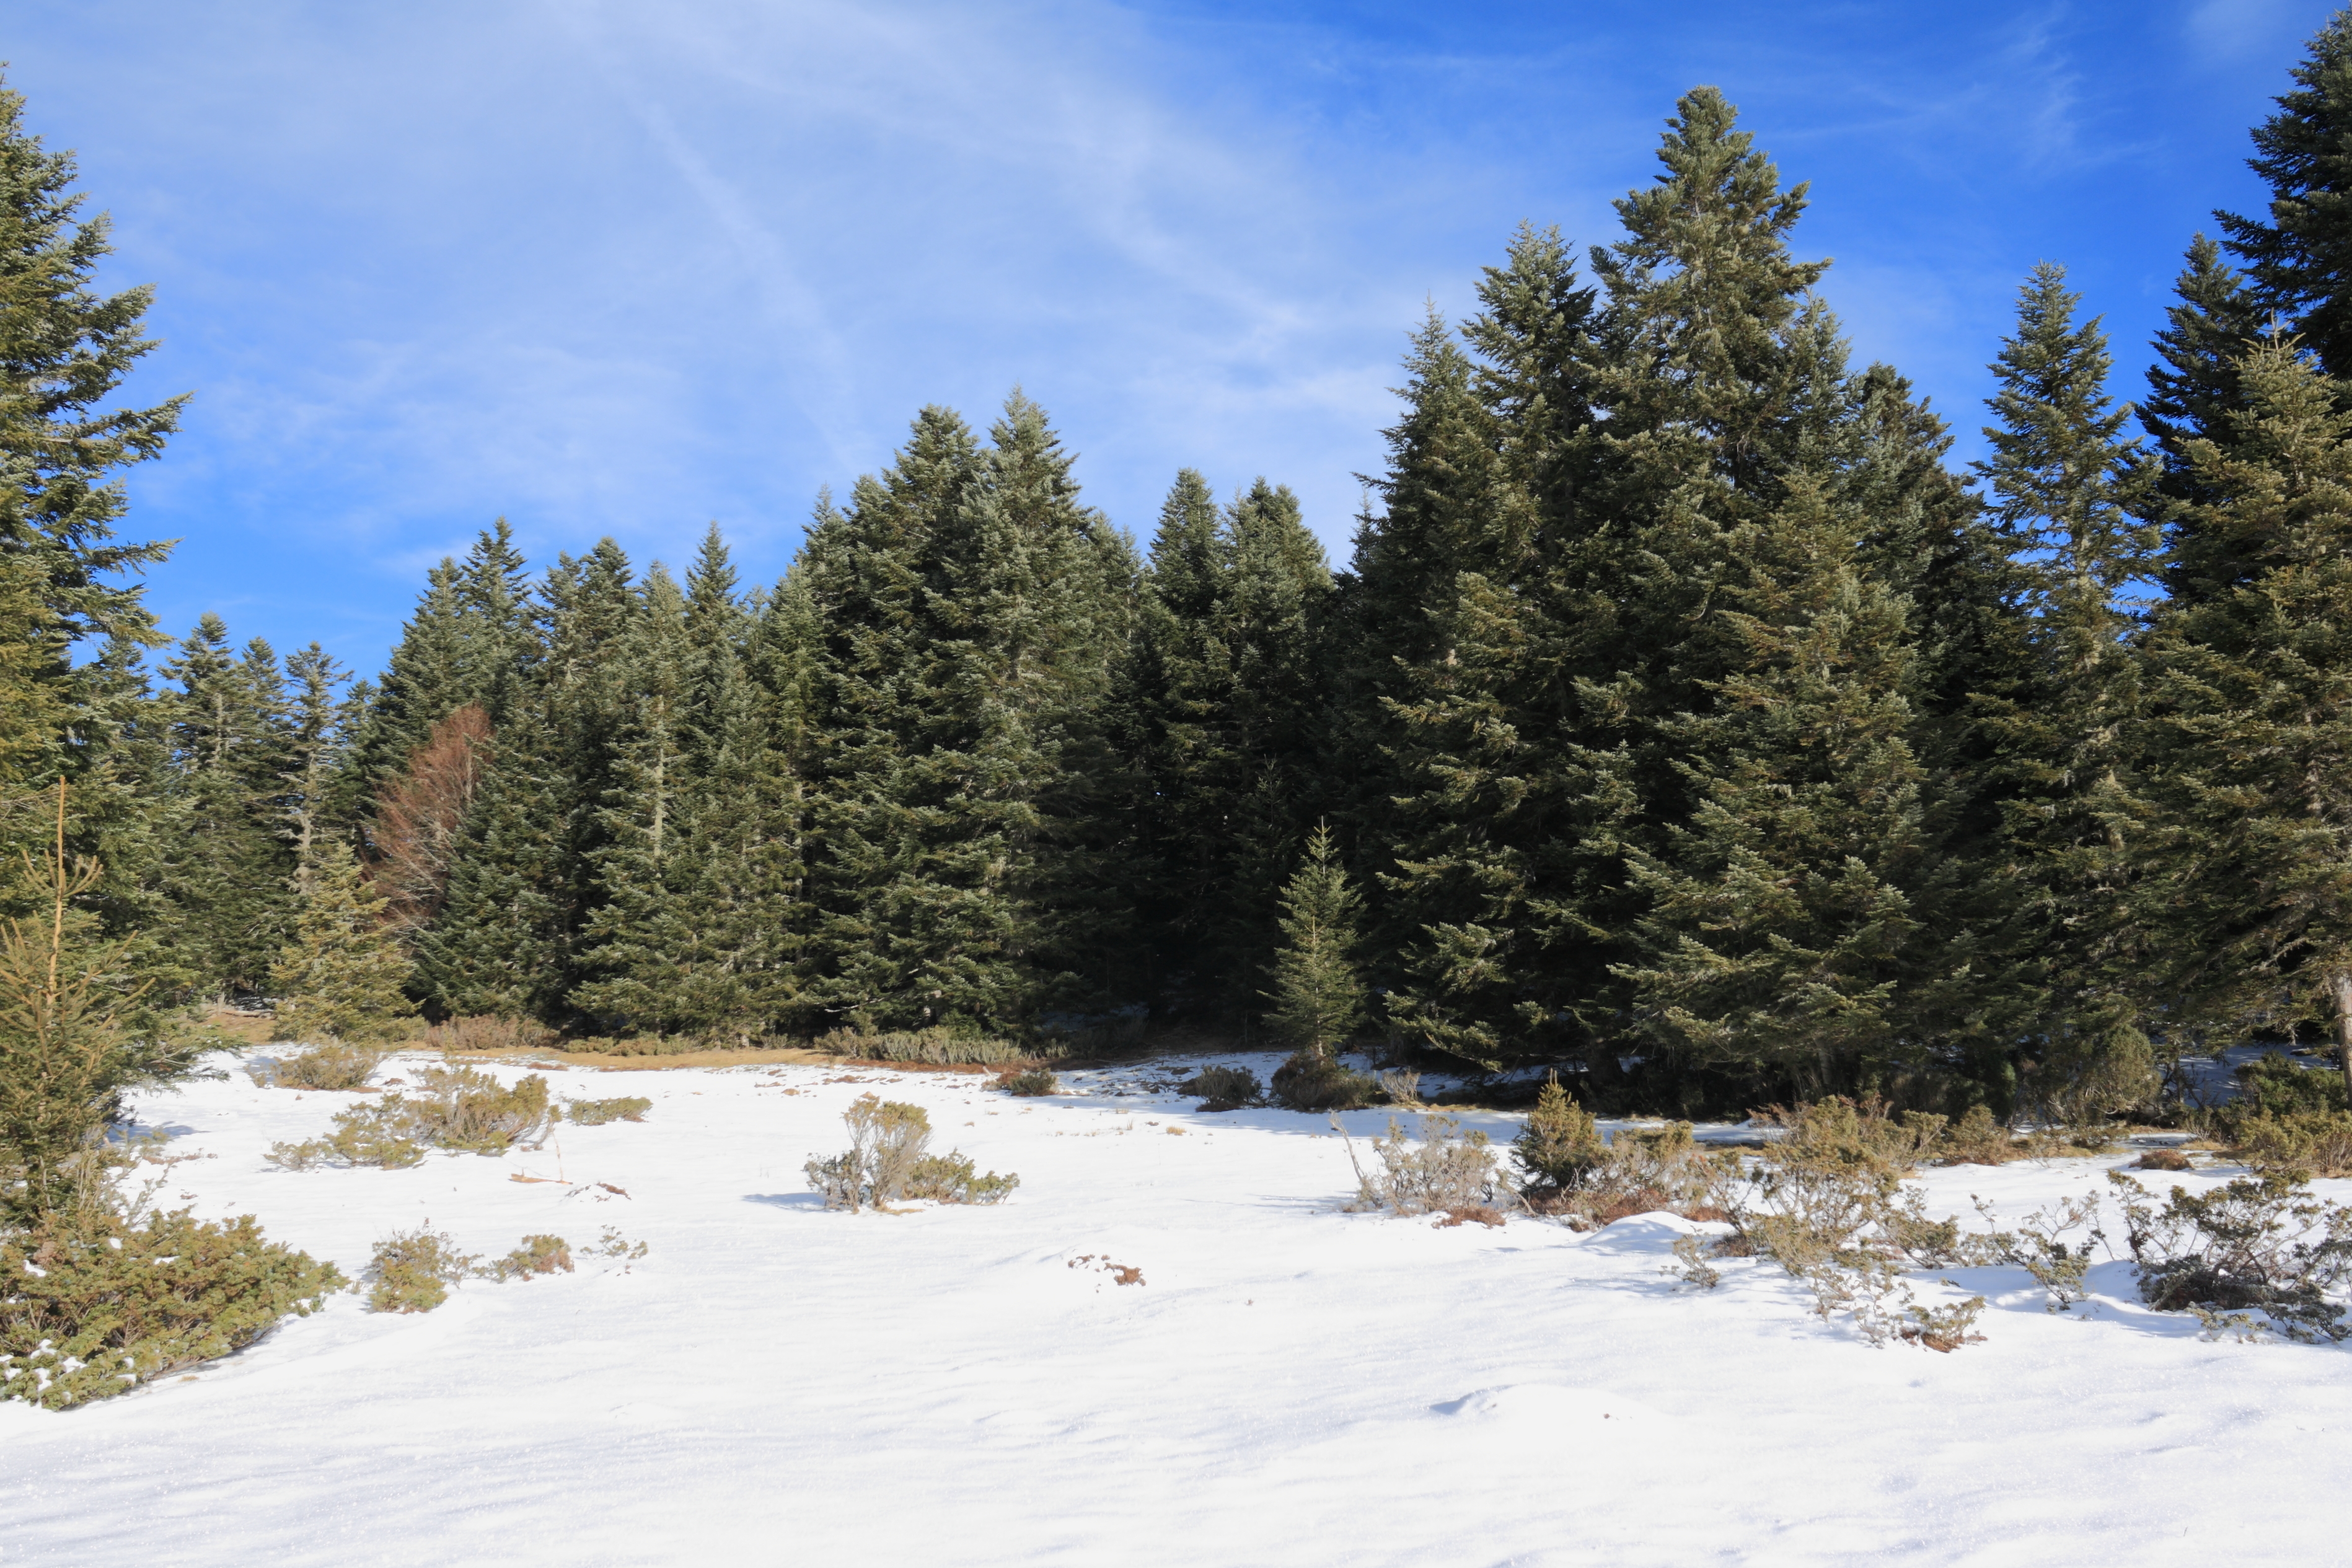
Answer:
top-left (1261, 823), bottom-right (1378, 1109)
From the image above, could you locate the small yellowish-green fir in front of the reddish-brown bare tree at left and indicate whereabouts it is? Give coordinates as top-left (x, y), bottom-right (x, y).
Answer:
top-left (270, 839), bottom-right (416, 1044)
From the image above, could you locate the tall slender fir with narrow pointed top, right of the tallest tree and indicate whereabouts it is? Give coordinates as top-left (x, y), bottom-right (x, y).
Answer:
top-left (1978, 263), bottom-right (2159, 1105)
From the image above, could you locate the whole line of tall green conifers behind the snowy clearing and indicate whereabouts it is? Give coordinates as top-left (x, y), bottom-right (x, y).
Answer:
top-left (14, 17), bottom-right (2352, 1117)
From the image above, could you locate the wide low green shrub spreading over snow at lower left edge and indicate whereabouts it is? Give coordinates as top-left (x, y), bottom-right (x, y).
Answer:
top-left (0, 1209), bottom-right (343, 1411)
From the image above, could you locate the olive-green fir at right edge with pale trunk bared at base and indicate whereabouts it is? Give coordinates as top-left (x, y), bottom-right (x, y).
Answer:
top-left (2133, 334), bottom-right (2352, 1084)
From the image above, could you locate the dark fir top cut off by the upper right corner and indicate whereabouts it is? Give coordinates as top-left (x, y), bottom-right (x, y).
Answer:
top-left (2213, 12), bottom-right (2352, 379)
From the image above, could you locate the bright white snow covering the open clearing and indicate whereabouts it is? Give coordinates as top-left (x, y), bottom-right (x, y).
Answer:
top-left (0, 1058), bottom-right (2352, 1568)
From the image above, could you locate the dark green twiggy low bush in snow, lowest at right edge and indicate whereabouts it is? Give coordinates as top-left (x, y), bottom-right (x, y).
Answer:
top-left (2107, 1171), bottom-right (2352, 1342)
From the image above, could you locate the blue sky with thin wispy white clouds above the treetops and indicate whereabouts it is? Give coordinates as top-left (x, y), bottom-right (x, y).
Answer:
top-left (0, 0), bottom-right (2331, 672)
